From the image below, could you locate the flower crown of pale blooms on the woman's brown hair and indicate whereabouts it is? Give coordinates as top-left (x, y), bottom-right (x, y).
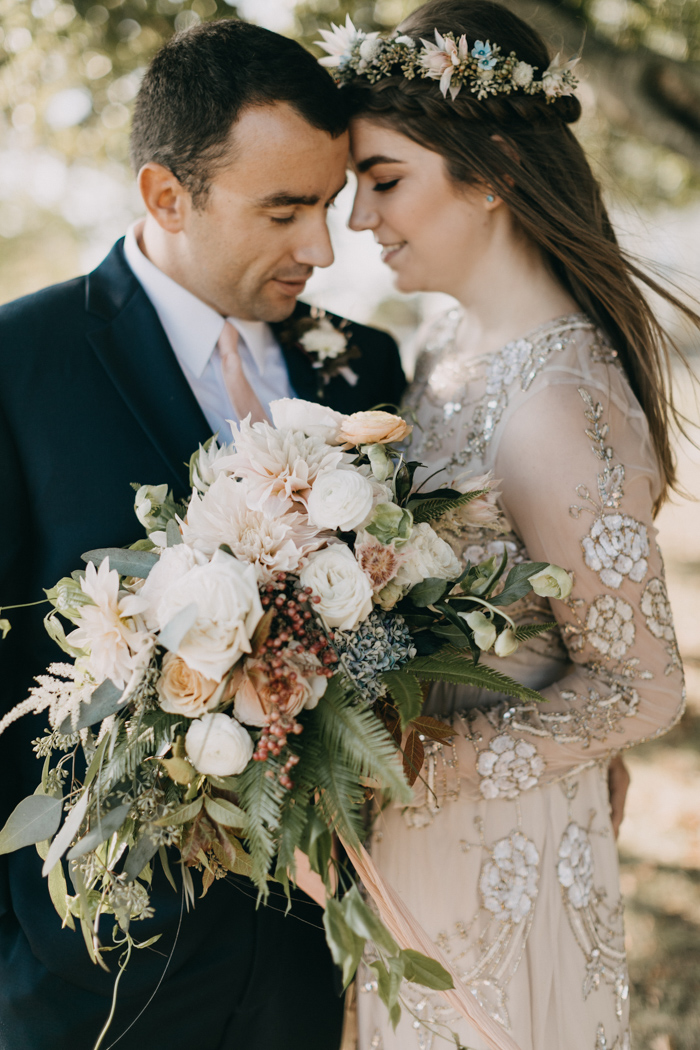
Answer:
top-left (317, 15), bottom-right (580, 103)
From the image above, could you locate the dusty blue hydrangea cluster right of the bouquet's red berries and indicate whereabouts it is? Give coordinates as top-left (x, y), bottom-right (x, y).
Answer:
top-left (334, 609), bottom-right (416, 704)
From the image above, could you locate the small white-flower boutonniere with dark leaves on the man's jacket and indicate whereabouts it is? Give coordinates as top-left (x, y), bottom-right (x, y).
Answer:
top-left (281, 307), bottom-right (361, 399)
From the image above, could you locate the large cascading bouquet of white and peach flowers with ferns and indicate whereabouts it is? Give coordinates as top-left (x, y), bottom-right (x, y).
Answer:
top-left (0, 399), bottom-right (571, 1041)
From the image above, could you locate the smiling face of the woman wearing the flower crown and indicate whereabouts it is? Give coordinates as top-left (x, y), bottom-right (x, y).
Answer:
top-left (348, 118), bottom-right (491, 298)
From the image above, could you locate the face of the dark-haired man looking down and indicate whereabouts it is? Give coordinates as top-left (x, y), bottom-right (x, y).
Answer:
top-left (177, 103), bottom-right (348, 321)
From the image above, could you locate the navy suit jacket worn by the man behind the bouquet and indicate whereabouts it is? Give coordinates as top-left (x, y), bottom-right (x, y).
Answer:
top-left (0, 242), bottom-right (404, 1033)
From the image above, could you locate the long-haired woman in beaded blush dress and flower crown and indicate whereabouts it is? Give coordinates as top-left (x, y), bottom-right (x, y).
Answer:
top-left (324, 0), bottom-right (695, 1050)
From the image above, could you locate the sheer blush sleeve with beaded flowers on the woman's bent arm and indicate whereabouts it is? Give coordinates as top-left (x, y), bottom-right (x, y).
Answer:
top-left (449, 366), bottom-right (683, 798)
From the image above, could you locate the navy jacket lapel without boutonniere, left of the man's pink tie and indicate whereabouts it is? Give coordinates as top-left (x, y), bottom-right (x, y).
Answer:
top-left (86, 242), bottom-right (211, 487)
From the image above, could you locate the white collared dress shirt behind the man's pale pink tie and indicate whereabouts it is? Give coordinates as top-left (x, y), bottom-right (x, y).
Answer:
top-left (124, 219), bottom-right (295, 442)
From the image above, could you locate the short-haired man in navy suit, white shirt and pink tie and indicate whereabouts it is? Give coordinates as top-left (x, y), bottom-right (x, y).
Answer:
top-left (0, 19), bottom-right (403, 1050)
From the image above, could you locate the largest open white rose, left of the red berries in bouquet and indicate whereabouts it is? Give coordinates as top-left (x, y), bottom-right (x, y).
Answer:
top-left (142, 544), bottom-right (262, 681)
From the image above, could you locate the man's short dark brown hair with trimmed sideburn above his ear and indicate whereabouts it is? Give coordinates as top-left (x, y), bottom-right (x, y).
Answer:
top-left (131, 18), bottom-right (349, 206)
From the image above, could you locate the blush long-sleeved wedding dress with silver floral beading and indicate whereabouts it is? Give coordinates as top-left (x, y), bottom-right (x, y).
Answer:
top-left (358, 310), bottom-right (683, 1050)
